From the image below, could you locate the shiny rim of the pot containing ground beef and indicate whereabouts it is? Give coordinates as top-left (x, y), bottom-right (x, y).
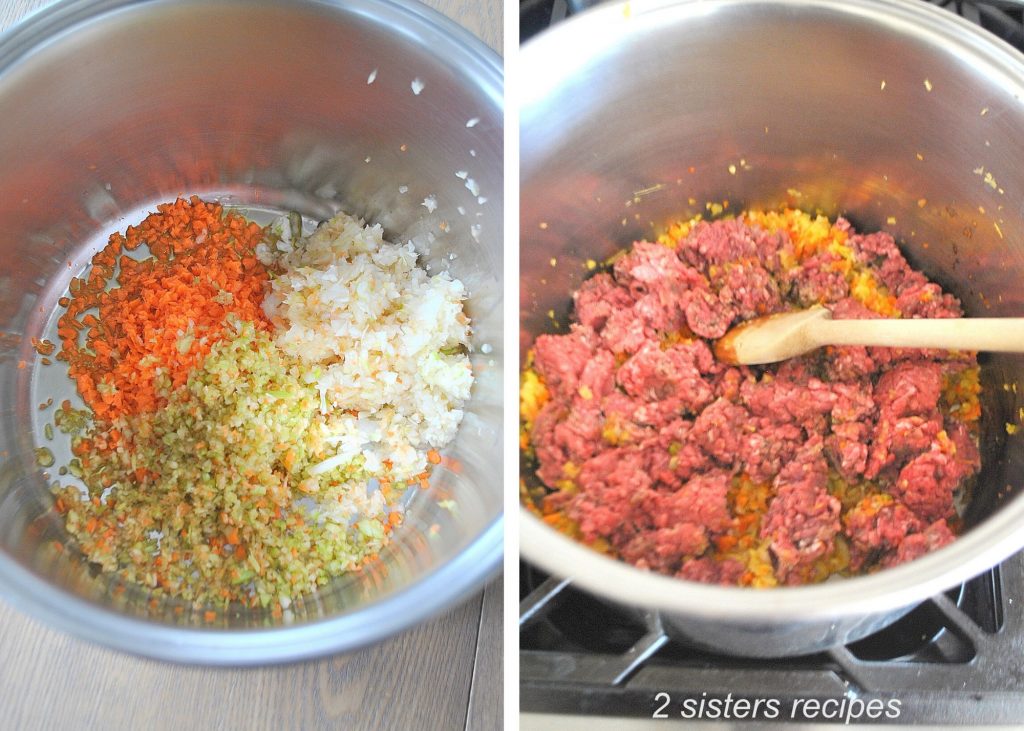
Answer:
top-left (519, 0), bottom-right (1024, 624)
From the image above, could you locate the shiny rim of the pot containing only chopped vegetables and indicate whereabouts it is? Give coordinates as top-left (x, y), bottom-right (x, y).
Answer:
top-left (0, 0), bottom-right (504, 665)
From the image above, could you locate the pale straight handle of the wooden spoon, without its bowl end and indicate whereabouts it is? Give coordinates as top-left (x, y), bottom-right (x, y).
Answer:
top-left (810, 317), bottom-right (1024, 353)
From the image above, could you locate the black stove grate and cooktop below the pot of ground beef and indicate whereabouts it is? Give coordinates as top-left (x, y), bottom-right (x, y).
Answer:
top-left (519, 554), bottom-right (1024, 725)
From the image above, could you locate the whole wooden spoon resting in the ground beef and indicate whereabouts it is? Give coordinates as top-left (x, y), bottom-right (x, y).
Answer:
top-left (715, 305), bottom-right (1024, 366)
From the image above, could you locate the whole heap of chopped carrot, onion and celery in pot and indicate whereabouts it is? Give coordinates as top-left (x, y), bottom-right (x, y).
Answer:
top-left (49, 197), bottom-right (473, 613)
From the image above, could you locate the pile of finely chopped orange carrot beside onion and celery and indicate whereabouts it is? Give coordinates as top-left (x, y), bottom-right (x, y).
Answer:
top-left (58, 197), bottom-right (271, 421)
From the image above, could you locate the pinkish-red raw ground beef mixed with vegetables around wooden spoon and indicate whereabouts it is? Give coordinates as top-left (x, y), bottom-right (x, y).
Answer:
top-left (527, 210), bottom-right (981, 586)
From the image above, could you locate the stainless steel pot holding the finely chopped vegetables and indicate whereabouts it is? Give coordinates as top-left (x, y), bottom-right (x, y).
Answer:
top-left (0, 0), bottom-right (503, 663)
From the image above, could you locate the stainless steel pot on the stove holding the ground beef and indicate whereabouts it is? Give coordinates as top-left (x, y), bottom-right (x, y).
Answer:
top-left (520, 0), bottom-right (1024, 656)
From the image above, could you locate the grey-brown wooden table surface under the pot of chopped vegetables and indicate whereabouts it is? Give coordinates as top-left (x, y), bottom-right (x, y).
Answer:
top-left (0, 0), bottom-right (503, 731)
